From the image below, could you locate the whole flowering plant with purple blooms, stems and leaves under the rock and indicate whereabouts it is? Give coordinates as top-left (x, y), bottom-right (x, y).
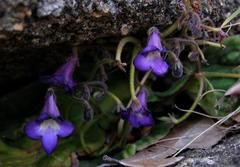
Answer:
top-left (0, 0), bottom-right (240, 167)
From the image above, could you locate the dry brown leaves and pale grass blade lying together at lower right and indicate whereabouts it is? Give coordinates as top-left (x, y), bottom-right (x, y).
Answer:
top-left (104, 115), bottom-right (237, 167)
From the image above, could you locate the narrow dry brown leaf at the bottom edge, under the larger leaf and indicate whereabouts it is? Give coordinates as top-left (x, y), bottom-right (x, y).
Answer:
top-left (119, 157), bottom-right (184, 167)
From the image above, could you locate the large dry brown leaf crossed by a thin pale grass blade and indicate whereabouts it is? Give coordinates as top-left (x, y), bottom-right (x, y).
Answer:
top-left (124, 118), bottom-right (226, 162)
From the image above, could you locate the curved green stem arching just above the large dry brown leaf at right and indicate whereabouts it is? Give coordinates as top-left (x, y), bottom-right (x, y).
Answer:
top-left (172, 77), bottom-right (204, 124)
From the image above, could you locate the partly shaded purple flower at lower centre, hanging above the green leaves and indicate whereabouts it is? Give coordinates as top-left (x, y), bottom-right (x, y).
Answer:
top-left (121, 89), bottom-right (153, 128)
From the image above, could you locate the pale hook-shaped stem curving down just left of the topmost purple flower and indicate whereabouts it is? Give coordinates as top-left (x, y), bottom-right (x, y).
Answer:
top-left (115, 36), bottom-right (140, 71)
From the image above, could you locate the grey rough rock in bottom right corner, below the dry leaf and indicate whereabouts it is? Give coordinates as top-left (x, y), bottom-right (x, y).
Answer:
top-left (175, 134), bottom-right (240, 167)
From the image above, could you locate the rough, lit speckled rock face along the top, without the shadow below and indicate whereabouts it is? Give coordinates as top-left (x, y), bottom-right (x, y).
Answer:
top-left (0, 0), bottom-right (240, 50)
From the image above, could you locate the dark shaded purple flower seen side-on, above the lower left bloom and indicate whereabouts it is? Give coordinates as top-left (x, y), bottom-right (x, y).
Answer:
top-left (41, 56), bottom-right (78, 91)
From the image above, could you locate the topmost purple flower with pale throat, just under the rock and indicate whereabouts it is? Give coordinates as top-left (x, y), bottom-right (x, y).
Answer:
top-left (133, 27), bottom-right (168, 76)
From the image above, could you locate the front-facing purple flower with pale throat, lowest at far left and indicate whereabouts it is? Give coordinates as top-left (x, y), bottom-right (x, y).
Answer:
top-left (24, 91), bottom-right (74, 155)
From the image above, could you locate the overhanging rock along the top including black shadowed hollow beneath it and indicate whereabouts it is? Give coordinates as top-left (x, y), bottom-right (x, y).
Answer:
top-left (0, 0), bottom-right (240, 82)
